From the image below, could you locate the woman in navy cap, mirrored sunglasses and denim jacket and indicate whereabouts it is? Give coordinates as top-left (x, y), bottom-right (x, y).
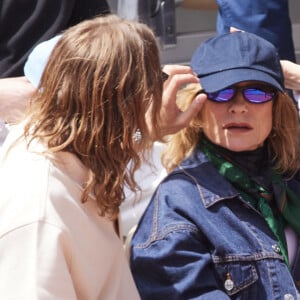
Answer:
top-left (130, 32), bottom-right (300, 300)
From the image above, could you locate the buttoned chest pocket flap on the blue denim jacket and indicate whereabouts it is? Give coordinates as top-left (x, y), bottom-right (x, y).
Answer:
top-left (213, 257), bottom-right (258, 296)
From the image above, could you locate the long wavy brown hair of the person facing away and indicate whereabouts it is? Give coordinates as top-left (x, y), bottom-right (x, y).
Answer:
top-left (25, 15), bottom-right (162, 218)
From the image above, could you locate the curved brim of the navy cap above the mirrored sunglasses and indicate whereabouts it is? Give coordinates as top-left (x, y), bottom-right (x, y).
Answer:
top-left (198, 68), bottom-right (284, 93)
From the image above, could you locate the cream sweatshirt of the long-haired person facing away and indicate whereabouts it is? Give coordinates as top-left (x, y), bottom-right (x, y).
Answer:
top-left (0, 128), bottom-right (139, 300)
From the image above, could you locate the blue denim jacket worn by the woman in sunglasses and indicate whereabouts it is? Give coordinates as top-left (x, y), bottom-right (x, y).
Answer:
top-left (130, 150), bottom-right (300, 300)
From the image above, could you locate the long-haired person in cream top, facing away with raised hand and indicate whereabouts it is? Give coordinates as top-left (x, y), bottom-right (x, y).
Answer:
top-left (0, 15), bottom-right (205, 300)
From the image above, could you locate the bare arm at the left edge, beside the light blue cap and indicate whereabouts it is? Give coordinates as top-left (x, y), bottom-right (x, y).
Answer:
top-left (0, 76), bottom-right (35, 123)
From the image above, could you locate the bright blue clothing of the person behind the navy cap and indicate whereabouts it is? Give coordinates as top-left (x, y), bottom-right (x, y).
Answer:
top-left (217, 0), bottom-right (295, 61)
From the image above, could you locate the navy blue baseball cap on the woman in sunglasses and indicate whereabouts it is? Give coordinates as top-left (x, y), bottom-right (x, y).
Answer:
top-left (191, 31), bottom-right (284, 93)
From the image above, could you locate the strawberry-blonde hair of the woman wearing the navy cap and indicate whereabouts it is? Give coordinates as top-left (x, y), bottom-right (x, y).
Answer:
top-left (162, 84), bottom-right (300, 174)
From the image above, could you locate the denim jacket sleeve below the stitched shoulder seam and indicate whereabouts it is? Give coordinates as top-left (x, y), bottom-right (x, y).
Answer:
top-left (131, 230), bottom-right (230, 300)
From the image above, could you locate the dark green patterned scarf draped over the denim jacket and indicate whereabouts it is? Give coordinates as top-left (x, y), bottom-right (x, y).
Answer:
top-left (200, 137), bottom-right (300, 265)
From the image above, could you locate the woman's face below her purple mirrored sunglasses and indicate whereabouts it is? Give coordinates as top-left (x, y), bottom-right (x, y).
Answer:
top-left (203, 81), bottom-right (273, 152)
